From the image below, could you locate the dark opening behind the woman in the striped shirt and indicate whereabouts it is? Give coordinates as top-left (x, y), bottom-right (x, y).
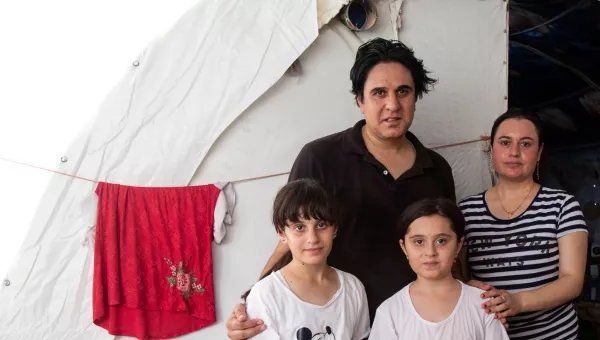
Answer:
top-left (508, 0), bottom-right (600, 334)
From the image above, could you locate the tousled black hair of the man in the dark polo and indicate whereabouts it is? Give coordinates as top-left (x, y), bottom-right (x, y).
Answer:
top-left (350, 38), bottom-right (437, 103)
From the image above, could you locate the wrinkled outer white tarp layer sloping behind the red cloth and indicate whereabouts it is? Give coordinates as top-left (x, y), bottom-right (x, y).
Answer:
top-left (0, 0), bottom-right (318, 339)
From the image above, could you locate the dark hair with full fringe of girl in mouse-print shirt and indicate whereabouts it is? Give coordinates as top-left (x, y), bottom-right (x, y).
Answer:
top-left (242, 179), bottom-right (339, 300)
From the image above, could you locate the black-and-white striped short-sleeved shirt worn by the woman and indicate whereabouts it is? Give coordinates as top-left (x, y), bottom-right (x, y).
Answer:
top-left (460, 187), bottom-right (587, 340)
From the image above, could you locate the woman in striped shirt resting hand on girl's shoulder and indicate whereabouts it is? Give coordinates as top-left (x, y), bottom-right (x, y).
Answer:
top-left (460, 111), bottom-right (587, 340)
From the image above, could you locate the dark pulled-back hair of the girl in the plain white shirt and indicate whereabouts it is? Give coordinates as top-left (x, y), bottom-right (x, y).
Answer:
top-left (397, 198), bottom-right (465, 240)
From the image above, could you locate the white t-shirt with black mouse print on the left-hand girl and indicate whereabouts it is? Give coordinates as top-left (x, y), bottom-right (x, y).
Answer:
top-left (246, 269), bottom-right (369, 340)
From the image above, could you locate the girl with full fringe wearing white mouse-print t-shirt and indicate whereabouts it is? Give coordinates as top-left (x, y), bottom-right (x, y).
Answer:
top-left (243, 179), bottom-right (370, 340)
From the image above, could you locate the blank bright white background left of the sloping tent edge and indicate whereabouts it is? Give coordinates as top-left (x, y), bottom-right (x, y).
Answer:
top-left (0, 0), bottom-right (196, 294)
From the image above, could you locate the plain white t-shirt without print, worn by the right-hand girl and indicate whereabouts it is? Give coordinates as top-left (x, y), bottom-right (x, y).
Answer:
top-left (369, 281), bottom-right (508, 340)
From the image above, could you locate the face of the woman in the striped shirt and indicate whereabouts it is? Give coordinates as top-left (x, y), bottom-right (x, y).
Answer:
top-left (492, 118), bottom-right (543, 180)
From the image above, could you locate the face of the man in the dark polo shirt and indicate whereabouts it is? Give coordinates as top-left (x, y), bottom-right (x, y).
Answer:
top-left (358, 62), bottom-right (416, 140)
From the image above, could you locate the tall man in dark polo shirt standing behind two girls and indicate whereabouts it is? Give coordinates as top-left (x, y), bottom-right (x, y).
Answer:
top-left (227, 38), bottom-right (456, 340)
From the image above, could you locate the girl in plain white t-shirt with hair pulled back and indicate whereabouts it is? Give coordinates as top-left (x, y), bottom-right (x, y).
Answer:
top-left (369, 199), bottom-right (508, 340)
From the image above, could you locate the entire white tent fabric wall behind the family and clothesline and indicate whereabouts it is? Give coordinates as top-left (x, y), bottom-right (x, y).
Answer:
top-left (0, 0), bottom-right (506, 339)
